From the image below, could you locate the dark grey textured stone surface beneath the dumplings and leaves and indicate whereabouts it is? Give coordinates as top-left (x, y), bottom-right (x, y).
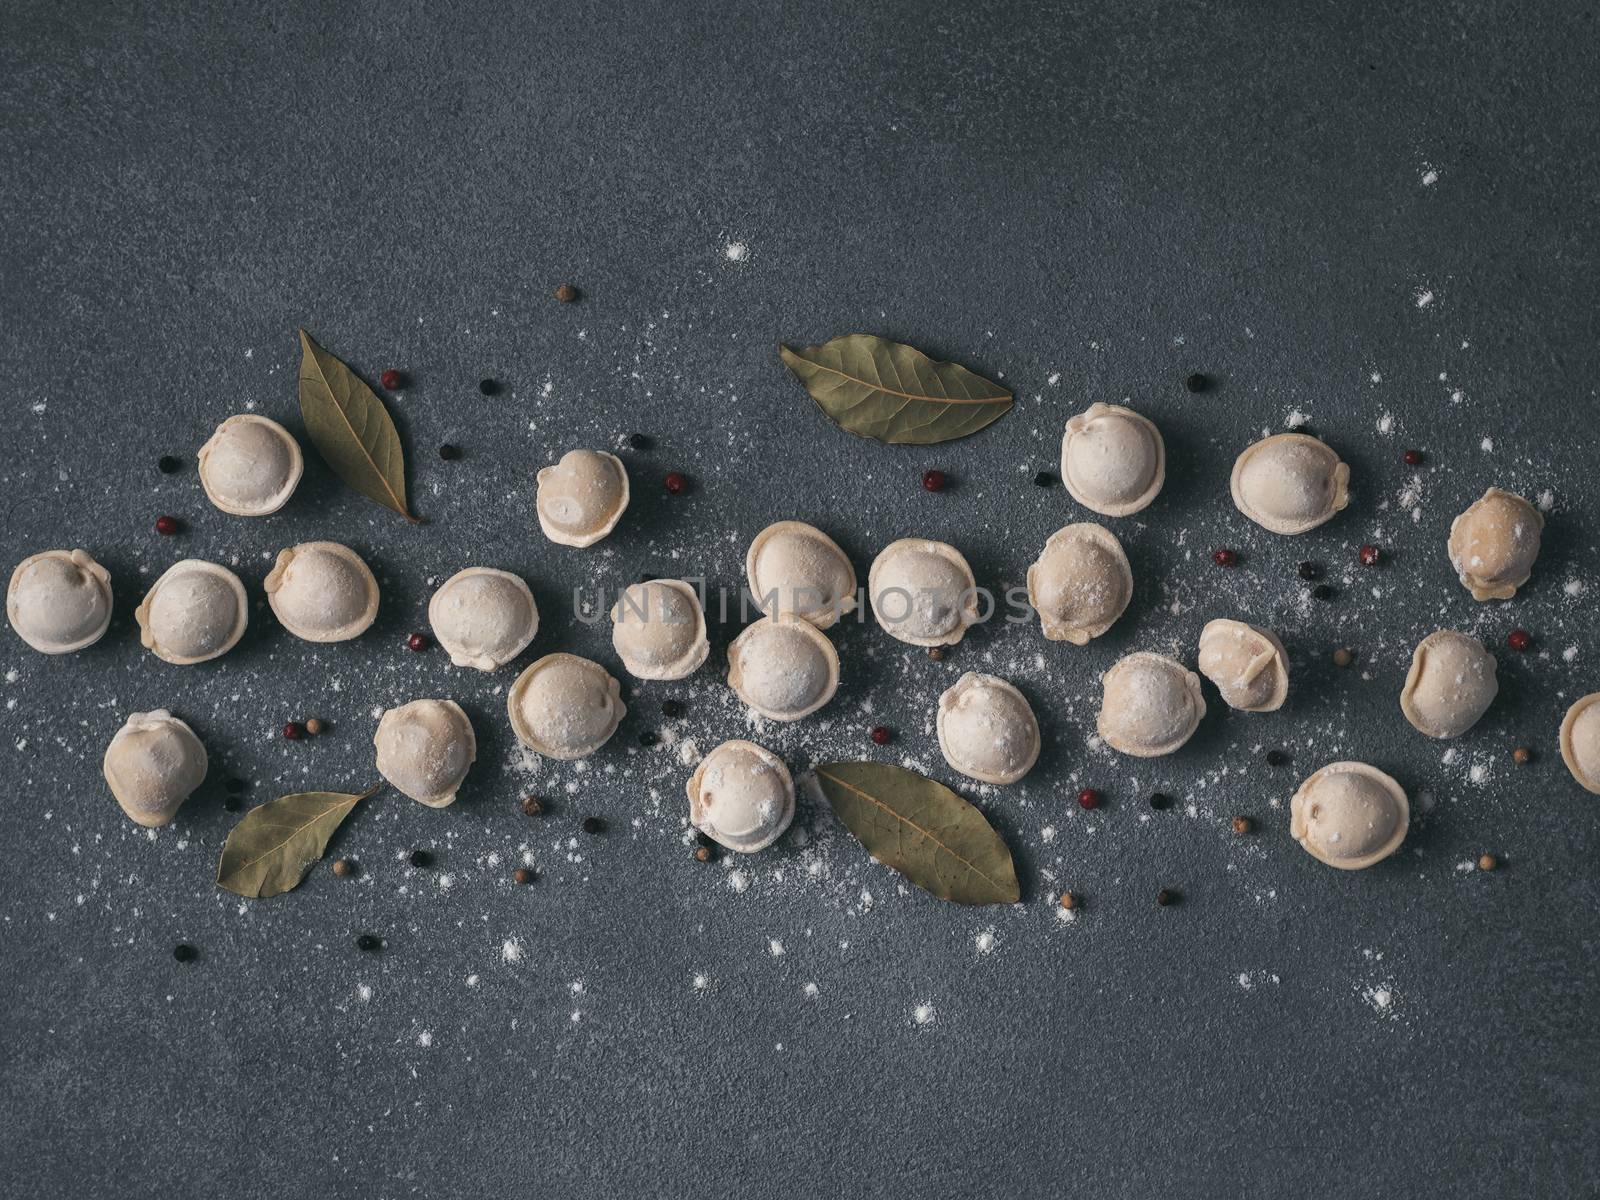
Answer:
top-left (0, 0), bottom-right (1600, 1197)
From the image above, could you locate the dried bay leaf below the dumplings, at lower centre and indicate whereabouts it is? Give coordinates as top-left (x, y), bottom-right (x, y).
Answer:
top-left (816, 763), bottom-right (1022, 904)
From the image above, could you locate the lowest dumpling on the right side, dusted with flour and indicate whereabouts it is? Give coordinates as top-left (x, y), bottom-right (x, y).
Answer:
top-left (1290, 763), bottom-right (1411, 870)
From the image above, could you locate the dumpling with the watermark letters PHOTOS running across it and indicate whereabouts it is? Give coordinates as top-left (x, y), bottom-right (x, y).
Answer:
top-left (867, 538), bottom-right (979, 646)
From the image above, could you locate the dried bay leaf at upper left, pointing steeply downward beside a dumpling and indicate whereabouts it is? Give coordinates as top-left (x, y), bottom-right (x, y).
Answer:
top-left (299, 330), bottom-right (419, 525)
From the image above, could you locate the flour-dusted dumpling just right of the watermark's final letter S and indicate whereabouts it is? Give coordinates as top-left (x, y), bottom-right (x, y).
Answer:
top-left (1027, 522), bottom-right (1133, 646)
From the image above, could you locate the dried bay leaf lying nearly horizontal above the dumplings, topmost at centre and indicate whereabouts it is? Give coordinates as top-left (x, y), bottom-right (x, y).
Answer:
top-left (778, 333), bottom-right (1011, 445)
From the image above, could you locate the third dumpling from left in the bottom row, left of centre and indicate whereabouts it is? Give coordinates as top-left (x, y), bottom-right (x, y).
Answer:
top-left (506, 653), bottom-right (627, 758)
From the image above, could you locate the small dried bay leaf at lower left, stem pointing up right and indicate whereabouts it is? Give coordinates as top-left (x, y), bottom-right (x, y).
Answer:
top-left (216, 784), bottom-right (378, 899)
